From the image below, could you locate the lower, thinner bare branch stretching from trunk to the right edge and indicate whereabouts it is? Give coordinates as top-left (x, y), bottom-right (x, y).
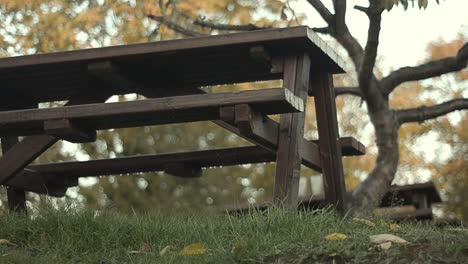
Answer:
top-left (396, 99), bottom-right (468, 125)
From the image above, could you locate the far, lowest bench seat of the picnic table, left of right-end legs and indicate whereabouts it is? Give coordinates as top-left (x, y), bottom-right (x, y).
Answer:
top-left (23, 146), bottom-right (275, 178)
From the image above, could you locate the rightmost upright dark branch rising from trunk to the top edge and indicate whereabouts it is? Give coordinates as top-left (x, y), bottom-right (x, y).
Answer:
top-left (358, 0), bottom-right (384, 103)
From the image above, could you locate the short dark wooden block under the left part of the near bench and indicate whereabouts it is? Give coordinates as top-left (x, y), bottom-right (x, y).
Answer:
top-left (44, 119), bottom-right (96, 143)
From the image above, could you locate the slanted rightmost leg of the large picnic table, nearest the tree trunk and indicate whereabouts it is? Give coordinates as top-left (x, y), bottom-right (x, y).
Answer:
top-left (309, 73), bottom-right (346, 213)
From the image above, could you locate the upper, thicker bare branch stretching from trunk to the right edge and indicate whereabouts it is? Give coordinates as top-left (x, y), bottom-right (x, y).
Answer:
top-left (382, 43), bottom-right (468, 95)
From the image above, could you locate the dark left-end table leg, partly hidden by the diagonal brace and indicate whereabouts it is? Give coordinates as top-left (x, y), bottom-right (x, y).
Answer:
top-left (2, 137), bottom-right (26, 212)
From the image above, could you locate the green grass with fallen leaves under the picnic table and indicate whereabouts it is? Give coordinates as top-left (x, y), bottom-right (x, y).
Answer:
top-left (0, 208), bottom-right (468, 264)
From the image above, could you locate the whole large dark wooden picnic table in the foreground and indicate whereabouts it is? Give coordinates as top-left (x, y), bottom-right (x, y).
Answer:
top-left (0, 27), bottom-right (364, 210)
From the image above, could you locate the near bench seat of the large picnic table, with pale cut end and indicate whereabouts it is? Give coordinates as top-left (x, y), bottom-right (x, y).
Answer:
top-left (0, 88), bottom-right (304, 134)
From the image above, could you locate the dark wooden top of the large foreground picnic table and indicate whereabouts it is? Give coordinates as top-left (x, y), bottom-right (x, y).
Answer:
top-left (0, 26), bottom-right (344, 105)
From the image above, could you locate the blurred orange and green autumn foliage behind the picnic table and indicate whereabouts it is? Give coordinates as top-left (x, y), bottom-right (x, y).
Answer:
top-left (0, 0), bottom-right (468, 219)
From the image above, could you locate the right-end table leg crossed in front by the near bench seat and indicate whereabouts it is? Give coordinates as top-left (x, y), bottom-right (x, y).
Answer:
top-left (273, 54), bottom-right (310, 209)
